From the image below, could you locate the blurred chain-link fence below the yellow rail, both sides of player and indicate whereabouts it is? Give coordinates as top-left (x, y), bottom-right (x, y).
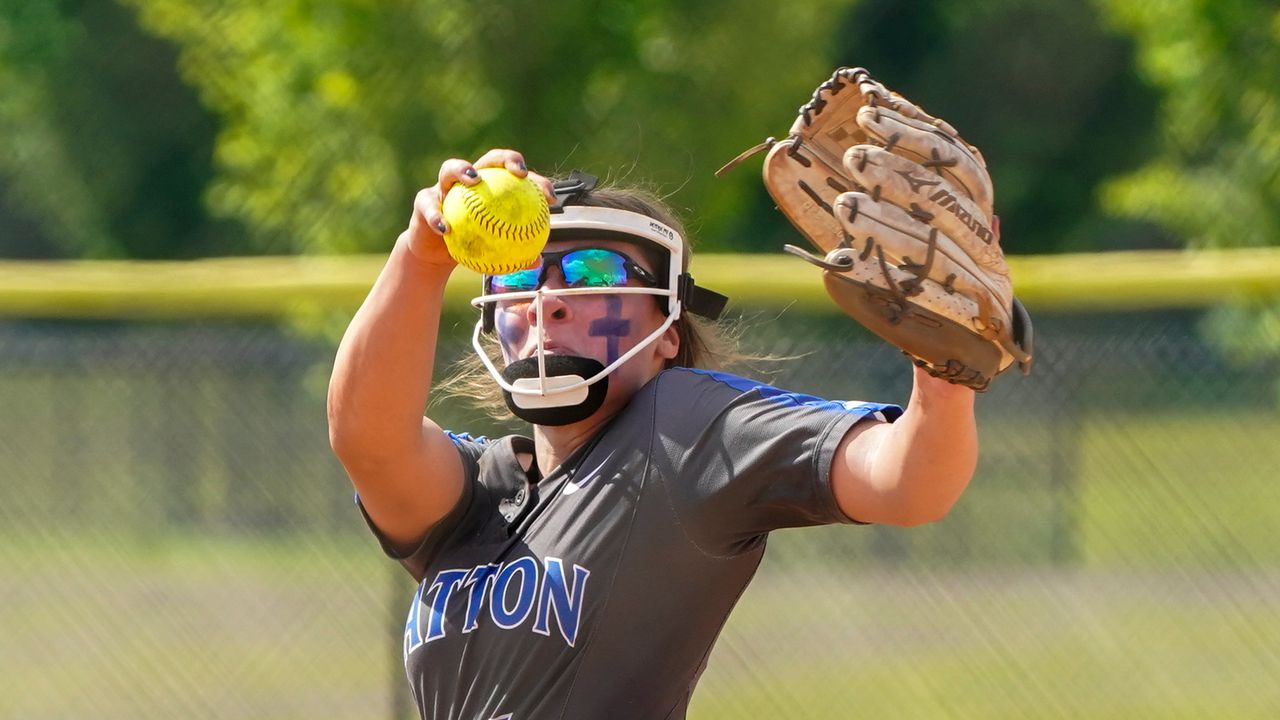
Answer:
top-left (0, 314), bottom-right (1280, 720)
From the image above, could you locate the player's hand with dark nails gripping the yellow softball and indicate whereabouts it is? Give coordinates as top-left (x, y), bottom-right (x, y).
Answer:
top-left (404, 149), bottom-right (556, 269)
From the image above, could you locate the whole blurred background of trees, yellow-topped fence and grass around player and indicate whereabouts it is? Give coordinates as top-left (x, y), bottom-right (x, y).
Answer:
top-left (10, 0), bottom-right (1280, 720)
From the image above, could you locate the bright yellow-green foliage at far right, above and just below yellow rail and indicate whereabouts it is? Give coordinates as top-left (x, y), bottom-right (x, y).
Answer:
top-left (1097, 0), bottom-right (1280, 363)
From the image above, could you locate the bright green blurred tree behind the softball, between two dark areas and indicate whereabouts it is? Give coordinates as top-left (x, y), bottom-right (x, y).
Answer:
top-left (125, 0), bottom-right (849, 252)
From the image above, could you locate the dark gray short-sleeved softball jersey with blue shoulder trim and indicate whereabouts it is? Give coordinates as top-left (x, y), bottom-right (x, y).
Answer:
top-left (360, 369), bottom-right (901, 720)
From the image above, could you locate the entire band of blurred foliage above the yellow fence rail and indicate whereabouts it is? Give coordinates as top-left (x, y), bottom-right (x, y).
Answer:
top-left (0, 0), bottom-right (1280, 258)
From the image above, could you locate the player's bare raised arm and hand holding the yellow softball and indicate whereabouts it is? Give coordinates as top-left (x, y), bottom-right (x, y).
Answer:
top-left (329, 150), bottom-right (549, 550)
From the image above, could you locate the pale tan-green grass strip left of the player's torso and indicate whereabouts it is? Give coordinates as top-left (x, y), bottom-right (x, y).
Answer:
top-left (0, 533), bottom-right (412, 719)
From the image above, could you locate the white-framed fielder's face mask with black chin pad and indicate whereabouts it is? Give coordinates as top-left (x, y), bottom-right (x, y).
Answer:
top-left (471, 170), bottom-right (727, 425)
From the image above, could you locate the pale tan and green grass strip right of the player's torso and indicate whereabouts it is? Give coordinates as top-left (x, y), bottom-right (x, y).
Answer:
top-left (691, 568), bottom-right (1280, 720)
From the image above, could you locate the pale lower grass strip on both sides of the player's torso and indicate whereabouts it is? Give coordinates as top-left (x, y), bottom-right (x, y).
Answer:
top-left (0, 530), bottom-right (1280, 720)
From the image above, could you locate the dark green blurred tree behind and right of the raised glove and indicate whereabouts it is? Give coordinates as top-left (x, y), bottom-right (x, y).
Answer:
top-left (808, 0), bottom-right (1171, 254)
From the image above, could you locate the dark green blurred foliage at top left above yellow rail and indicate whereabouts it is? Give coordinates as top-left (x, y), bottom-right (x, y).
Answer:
top-left (0, 0), bottom-right (232, 258)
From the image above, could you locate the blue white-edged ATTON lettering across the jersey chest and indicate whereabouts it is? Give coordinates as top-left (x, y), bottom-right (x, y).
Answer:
top-left (404, 556), bottom-right (591, 662)
